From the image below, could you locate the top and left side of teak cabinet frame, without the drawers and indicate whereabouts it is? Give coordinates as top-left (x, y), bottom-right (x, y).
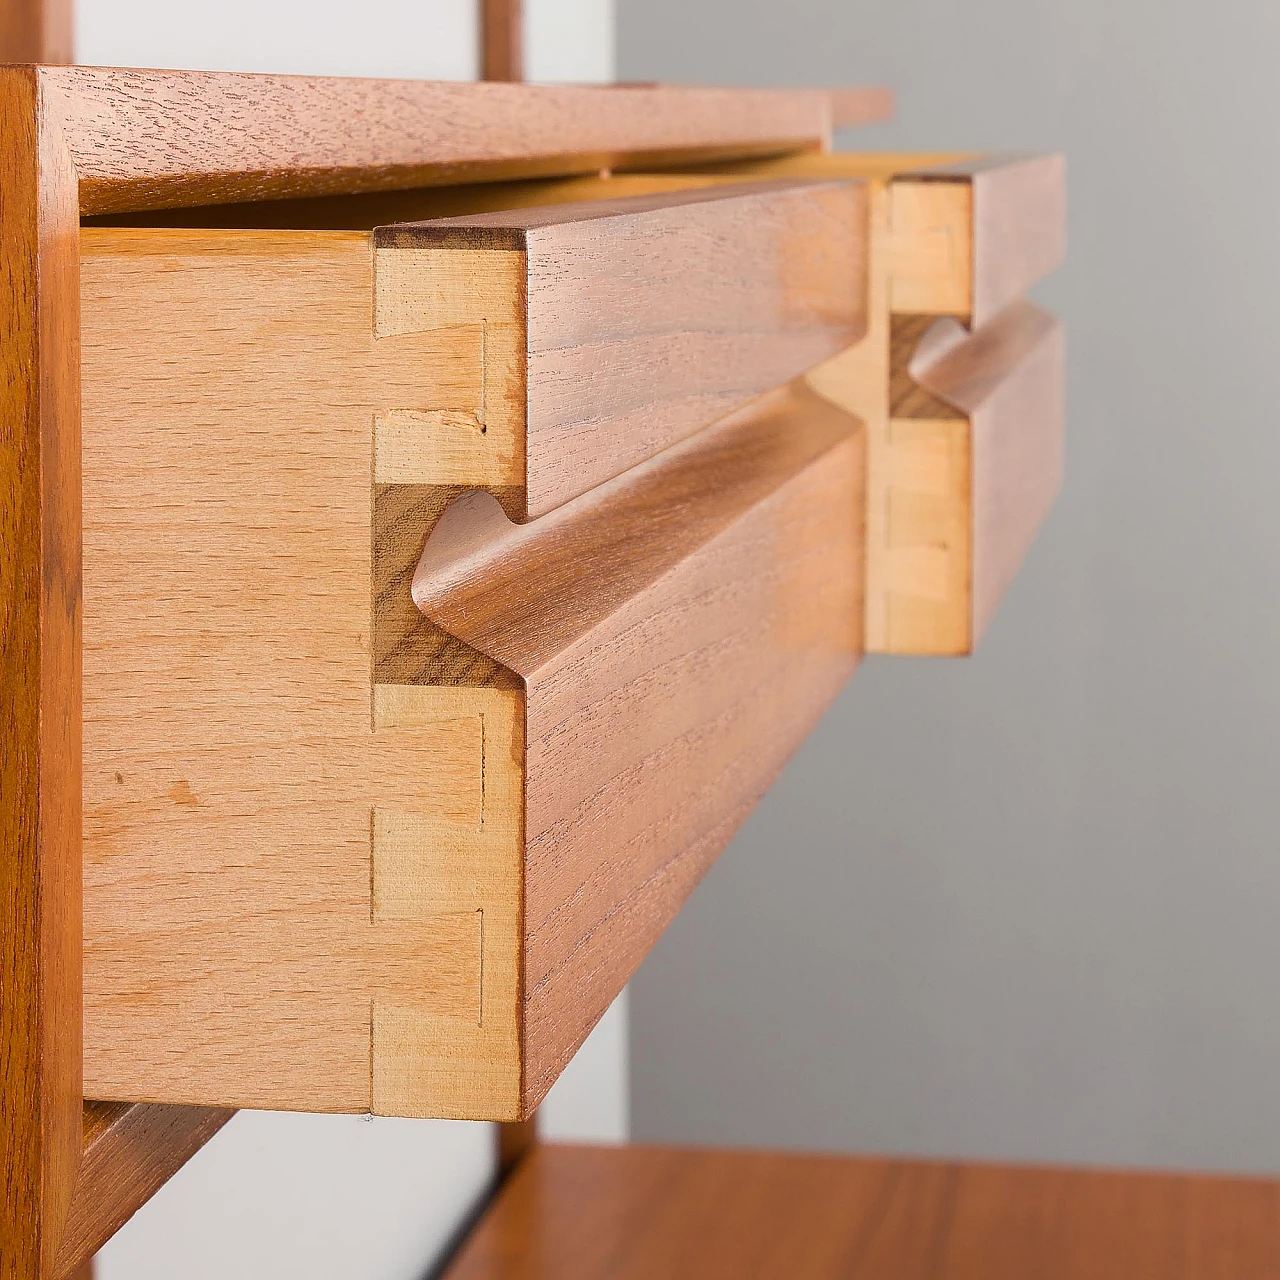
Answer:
top-left (0, 67), bottom-right (870, 1280)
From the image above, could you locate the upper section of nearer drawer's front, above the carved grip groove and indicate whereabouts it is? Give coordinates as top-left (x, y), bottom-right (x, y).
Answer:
top-left (376, 180), bottom-right (867, 520)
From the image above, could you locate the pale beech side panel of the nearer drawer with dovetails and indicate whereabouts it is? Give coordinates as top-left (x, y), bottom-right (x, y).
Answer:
top-left (82, 229), bottom-right (518, 1114)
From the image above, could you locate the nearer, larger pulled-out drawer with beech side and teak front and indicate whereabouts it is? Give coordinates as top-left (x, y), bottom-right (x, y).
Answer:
top-left (81, 179), bottom-right (867, 1119)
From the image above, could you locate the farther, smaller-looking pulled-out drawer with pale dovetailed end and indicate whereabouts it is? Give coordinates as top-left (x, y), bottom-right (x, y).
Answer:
top-left (722, 152), bottom-right (1065, 655)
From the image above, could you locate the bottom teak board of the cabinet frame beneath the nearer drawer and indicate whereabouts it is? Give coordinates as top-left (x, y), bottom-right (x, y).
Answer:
top-left (55, 1102), bottom-right (234, 1280)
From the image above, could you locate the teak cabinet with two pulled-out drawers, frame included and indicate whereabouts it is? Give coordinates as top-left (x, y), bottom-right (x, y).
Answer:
top-left (0, 68), bottom-right (1061, 1280)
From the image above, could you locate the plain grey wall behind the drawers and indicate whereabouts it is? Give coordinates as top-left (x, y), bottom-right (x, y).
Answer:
top-left (618, 0), bottom-right (1280, 1170)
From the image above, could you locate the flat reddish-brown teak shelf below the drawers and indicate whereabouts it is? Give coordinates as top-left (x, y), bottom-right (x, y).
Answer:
top-left (442, 1144), bottom-right (1280, 1280)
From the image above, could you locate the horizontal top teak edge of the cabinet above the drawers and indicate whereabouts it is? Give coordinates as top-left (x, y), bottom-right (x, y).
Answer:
top-left (40, 67), bottom-right (831, 214)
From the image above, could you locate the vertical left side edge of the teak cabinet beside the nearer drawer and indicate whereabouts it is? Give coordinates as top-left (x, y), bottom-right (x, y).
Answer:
top-left (0, 67), bottom-right (81, 1280)
